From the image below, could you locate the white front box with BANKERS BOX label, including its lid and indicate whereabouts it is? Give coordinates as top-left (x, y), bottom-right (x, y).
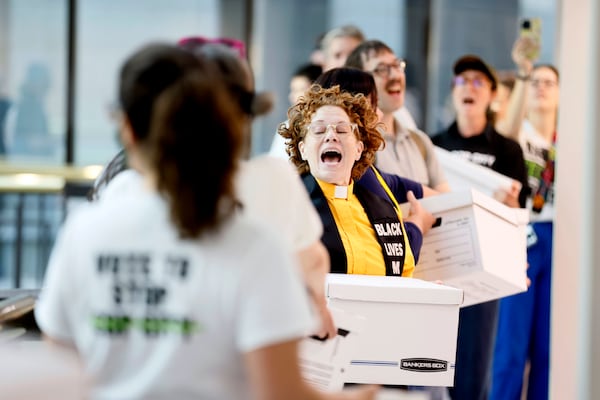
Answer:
top-left (327, 274), bottom-right (463, 386)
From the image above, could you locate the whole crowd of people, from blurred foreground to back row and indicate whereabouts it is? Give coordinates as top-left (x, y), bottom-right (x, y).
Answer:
top-left (35, 21), bottom-right (559, 400)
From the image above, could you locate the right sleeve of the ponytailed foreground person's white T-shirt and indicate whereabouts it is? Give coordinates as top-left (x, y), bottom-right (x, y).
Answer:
top-left (236, 228), bottom-right (316, 352)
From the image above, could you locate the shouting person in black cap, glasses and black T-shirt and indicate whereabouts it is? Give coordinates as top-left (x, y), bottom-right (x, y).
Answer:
top-left (432, 55), bottom-right (528, 400)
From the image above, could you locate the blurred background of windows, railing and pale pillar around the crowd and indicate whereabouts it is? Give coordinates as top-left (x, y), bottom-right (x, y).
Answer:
top-left (0, 0), bottom-right (600, 399)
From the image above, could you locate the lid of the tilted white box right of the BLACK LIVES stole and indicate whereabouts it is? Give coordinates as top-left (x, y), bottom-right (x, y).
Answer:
top-left (401, 189), bottom-right (529, 226)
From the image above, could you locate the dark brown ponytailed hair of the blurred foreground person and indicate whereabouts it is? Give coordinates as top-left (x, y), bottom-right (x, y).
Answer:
top-left (119, 44), bottom-right (243, 238)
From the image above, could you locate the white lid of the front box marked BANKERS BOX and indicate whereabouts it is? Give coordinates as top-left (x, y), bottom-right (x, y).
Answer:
top-left (327, 274), bottom-right (463, 305)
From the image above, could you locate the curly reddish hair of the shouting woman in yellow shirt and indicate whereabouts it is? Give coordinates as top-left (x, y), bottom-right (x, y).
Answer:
top-left (277, 84), bottom-right (384, 180)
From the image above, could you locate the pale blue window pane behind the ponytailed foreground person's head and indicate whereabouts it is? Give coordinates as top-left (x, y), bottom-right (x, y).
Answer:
top-left (75, 0), bottom-right (219, 165)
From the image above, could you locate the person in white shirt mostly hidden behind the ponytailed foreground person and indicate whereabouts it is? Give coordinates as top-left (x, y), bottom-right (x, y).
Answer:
top-left (91, 36), bottom-right (337, 337)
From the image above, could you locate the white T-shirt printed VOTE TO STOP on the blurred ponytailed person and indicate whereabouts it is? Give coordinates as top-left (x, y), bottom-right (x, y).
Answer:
top-left (35, 177), bottom-right (313, 399)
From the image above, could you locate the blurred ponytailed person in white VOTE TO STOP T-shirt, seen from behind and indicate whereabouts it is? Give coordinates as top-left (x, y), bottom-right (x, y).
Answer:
top-left (35, 44), bottom-right (376, 400)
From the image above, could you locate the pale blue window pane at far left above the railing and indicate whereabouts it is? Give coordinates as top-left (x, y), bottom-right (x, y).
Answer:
top-left (0, 0), bottom-right (67, 163)
